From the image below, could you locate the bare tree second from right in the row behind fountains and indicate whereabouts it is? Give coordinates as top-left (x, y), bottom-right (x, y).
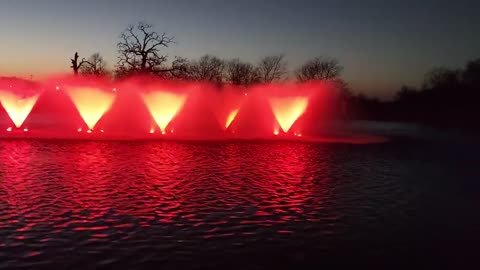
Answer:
top-left (257, 55), bottom-right (287, 83)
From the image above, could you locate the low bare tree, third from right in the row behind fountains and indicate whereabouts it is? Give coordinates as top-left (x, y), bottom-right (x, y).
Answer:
top-left (225, 59), bottom-right (260, 86)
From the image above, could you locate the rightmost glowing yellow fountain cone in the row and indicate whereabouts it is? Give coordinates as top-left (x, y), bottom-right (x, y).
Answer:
top-left (270, 97), bottom-right (308, 132)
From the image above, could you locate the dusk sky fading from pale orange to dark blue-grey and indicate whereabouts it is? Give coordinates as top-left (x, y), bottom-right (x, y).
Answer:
top-left (0, 0), bottom-right (480, 97)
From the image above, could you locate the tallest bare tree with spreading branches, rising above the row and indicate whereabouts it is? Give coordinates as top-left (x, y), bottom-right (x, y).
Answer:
top-left (117, 22), bottom-right (174, 74)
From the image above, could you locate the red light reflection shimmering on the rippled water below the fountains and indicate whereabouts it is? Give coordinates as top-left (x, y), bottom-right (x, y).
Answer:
top-left (0, 141), bottom-right (336, 239)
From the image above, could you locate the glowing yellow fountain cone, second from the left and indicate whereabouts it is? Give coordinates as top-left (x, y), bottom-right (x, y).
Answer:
top-left (67, 87), bottom-right (115, 130)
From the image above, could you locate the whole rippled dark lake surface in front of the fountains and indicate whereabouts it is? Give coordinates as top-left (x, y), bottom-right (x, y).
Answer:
top-left (0, 140), bottom-right (480, 269)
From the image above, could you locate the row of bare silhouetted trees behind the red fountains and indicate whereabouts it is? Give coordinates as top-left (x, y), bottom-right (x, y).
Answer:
top-left (70, 22), bottom-right (343, 86)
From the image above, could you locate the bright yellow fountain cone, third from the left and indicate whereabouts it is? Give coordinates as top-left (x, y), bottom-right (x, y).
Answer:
top-left (142, 91), bottom-right (186, 132)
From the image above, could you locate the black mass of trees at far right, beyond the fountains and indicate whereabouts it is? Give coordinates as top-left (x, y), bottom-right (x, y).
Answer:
top-left (347, 58), bottom-right (480, 132)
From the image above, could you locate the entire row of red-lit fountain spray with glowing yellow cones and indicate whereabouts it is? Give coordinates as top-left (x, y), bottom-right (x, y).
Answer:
top-left (0, 78), bottom-right (386, 141)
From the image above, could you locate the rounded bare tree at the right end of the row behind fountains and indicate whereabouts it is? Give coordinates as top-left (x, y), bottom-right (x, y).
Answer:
top-left (296, 57), bottom-right (343, 82)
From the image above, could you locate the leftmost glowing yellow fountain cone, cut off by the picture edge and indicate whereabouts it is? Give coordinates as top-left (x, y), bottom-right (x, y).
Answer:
top-left (0, 90), bottom-right (40, 128)
